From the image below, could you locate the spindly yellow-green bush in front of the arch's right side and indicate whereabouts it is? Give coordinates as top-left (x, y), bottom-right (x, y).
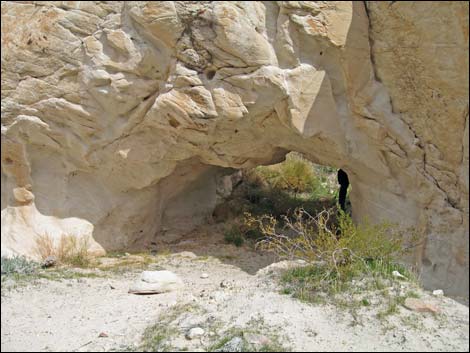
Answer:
top-left (247, 209), bottom-right (416, 296)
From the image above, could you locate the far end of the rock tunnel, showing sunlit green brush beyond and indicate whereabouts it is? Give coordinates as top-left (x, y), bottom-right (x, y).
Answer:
top-left (213, 152), bottom-right (352, 222)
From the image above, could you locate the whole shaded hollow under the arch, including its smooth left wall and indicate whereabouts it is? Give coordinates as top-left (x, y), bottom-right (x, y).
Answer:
top-left (144, 152), bottom-right (352, 273)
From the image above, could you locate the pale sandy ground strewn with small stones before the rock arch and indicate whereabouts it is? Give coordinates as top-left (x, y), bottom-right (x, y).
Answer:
top-left (1, 224), bottom-right (469, 352)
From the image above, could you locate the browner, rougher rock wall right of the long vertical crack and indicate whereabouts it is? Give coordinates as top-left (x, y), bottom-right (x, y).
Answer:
top-left (368, 2), bottom-right (469, 295)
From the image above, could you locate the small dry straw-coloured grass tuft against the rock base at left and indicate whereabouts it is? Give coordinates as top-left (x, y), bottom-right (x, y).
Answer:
top-left (35, 233), bottom-right (90, 267)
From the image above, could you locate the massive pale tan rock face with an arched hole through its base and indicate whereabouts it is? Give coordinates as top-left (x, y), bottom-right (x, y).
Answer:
top-left (1, 1), bottom-right (469, 295)
